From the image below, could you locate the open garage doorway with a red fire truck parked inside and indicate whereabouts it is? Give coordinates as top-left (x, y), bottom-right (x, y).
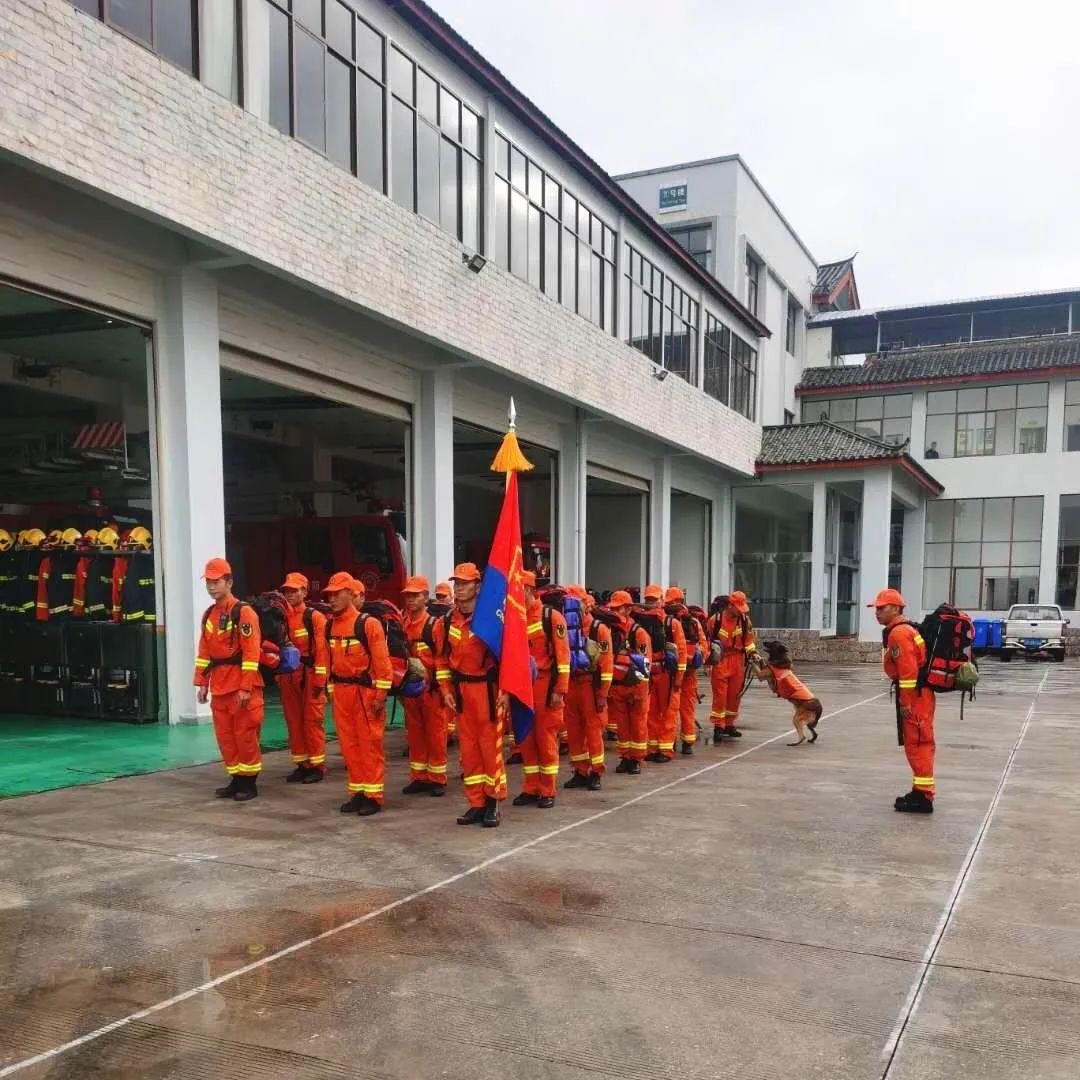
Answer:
top-left (221, 352), bottom-right (410, 603)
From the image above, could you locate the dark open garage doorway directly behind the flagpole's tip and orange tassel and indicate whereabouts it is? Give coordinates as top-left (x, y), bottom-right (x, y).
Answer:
top-left (447, 420), bottom-right (558, 582)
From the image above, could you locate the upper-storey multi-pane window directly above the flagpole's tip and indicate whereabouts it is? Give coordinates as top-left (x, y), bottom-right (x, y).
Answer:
top-left (489, 135), bottom-right (616, 334)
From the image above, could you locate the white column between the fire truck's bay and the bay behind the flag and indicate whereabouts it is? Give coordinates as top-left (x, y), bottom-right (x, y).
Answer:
top-left (411, 370), bottom-right (454, 586)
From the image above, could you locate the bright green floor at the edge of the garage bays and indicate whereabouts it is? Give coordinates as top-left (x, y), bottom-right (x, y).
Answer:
top-left (0, 701), bottom-right (402, 798)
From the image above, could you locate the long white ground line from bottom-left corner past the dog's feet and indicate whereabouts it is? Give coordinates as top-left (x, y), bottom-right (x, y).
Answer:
top-left (0, 693), bottom-right (885, 1077)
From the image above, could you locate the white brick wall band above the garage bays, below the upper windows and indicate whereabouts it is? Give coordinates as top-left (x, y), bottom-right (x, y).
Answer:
top-left (0, 0), bottom-right (760, 474)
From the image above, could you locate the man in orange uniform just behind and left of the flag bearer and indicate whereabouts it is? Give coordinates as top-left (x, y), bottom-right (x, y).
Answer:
top-left (402, 577), bottom-right (446, 796)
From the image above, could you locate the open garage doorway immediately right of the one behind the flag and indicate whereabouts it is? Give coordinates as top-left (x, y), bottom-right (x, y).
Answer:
top-left (585, 462), bottom-right (649, 599)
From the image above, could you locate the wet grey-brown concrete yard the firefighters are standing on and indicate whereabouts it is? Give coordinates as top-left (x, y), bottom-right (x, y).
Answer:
top-left (0, 661), bottom-right (1080, 1080)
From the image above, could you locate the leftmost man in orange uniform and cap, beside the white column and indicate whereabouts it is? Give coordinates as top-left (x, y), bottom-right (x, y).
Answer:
top-left (194, 558), bottom-right (262, 802)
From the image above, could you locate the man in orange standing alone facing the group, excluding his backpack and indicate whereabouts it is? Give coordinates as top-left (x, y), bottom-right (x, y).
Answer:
top-left (867, 589), bottom-right (936, 813)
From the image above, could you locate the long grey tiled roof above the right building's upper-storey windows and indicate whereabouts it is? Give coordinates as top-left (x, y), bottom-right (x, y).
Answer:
top-left (797, 334), bottom-right (1080, 392)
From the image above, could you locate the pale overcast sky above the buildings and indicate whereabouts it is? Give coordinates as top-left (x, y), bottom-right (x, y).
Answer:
top-left (430, 0), bottom-right (1080, 307)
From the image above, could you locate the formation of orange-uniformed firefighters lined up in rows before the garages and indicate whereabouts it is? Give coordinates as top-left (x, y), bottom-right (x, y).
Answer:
top-left (194, 558), bottom-right (756, 827)
